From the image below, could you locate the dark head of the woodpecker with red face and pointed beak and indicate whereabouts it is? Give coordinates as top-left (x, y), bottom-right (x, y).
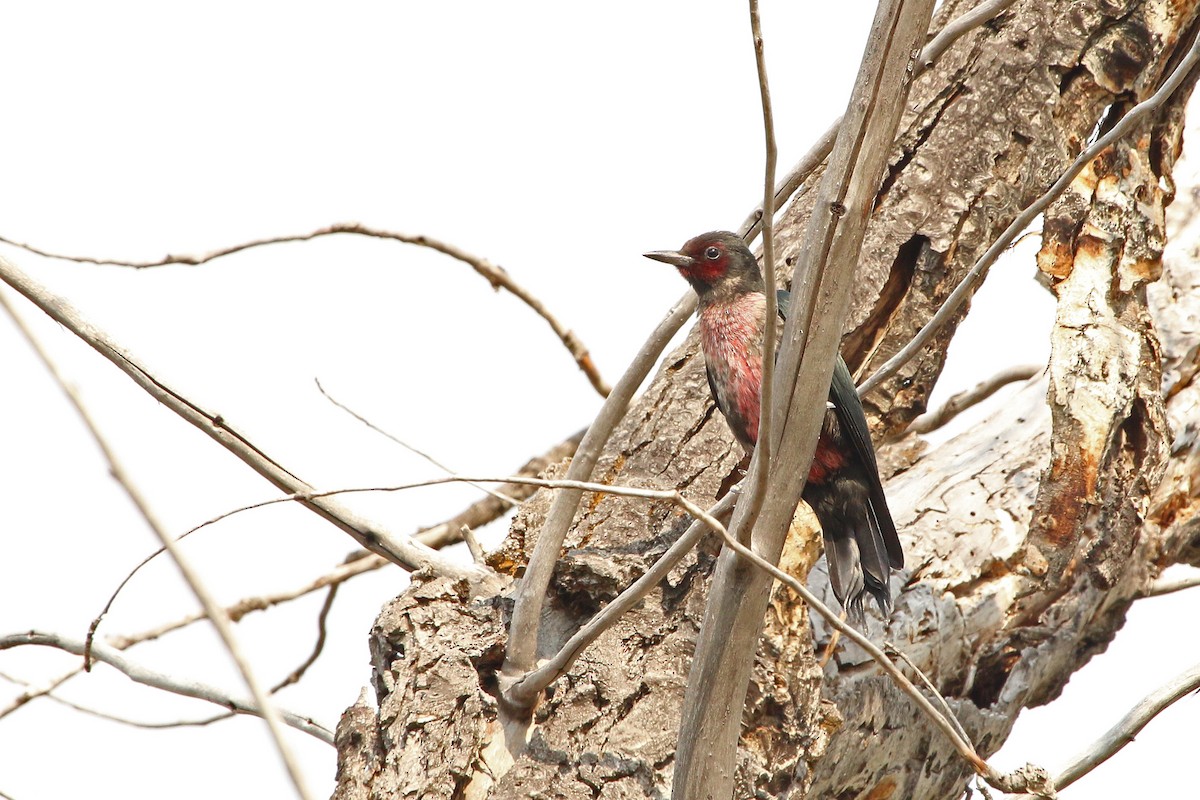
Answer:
top-left (646, 230), bottom-right (763, 302)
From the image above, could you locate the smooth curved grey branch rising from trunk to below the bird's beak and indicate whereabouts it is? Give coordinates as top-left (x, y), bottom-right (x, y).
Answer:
top-left (500, 291), bottom-right (696, 688)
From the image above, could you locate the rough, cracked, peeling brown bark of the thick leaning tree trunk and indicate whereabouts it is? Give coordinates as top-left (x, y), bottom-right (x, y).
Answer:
top-left (335, 0), bottom-right (1200, 800)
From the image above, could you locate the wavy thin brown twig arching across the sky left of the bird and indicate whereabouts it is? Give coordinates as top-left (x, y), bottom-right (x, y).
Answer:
top-left (0, 222), bottom-right (612, 397)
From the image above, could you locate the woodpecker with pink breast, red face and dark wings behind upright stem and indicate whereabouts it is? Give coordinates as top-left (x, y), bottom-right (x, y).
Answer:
top-left (644, 230), bottom-right (904, 626)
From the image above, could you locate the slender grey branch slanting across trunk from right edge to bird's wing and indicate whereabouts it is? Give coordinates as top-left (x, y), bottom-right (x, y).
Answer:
top-left (858, 33), bottom-right (1200, 396)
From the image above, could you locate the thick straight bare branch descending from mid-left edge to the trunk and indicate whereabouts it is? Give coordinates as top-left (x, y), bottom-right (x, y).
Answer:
top-left (0, 258), bottom-right (497, 590)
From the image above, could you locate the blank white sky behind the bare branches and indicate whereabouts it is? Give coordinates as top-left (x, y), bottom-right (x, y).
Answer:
top-left (0, 0), bottom-right (1200, 800)
